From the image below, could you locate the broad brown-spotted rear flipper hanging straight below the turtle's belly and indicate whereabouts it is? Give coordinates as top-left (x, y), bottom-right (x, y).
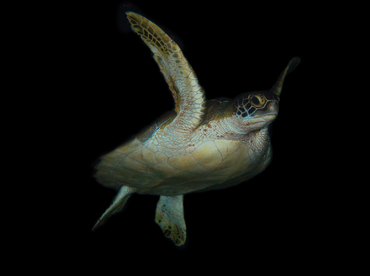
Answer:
top-left (155, 195), bottom-right (186, 246)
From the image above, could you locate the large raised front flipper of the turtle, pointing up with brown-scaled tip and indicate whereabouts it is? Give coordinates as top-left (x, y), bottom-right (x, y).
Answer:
top-left (126, 12), bottom-right (205, 133)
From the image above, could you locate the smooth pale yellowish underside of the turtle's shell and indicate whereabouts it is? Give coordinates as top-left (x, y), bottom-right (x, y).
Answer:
top-left (95, 116), bottom-right (270, 196)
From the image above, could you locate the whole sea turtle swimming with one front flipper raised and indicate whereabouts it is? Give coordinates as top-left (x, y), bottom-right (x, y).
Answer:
top-left (94, 12), bottom-right (300, 246)
